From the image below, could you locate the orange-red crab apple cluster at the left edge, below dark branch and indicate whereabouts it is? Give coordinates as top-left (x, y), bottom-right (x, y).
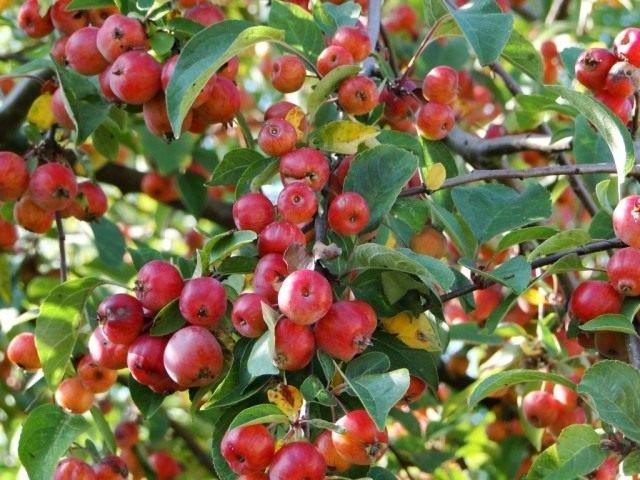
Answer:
top-left (0, 152), bottom-right (107, 244)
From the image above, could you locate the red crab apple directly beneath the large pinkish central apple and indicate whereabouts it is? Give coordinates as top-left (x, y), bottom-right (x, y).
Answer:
top-left (273, 317), bottom-right (316, 371)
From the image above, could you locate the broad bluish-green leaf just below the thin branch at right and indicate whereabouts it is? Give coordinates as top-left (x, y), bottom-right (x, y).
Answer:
top-left (451, 182), bottom-right (551, 243)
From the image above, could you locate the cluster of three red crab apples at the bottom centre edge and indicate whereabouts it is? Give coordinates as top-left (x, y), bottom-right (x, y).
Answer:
top-left (220, 410), bottom-right (389, 480)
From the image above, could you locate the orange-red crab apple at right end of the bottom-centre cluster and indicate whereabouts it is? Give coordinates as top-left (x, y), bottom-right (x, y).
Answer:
top-left (331, 409), bottom-right (389, 465)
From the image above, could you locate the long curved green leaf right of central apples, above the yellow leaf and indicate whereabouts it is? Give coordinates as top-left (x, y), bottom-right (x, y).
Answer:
top-left (351, 243), bottom-right (454, 290)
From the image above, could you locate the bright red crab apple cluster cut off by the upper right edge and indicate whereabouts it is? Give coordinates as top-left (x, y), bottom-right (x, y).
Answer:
top-left (575, 27), bottom-right (640, 125)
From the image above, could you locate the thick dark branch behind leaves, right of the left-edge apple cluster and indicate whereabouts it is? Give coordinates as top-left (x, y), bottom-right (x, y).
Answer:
top-left (96, 163), bottom-right (234, 228)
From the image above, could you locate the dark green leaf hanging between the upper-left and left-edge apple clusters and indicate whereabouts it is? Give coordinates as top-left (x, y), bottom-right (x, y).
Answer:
top-left (54, 63), bottom-right (111, 144)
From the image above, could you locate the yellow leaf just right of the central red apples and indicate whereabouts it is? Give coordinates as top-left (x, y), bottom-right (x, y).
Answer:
top-left (382, 312), bottom-right (442, 352)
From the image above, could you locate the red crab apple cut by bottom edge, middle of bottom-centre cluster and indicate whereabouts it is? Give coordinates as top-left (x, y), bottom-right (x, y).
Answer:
top-left (269, 442), bottom-right (327, 480)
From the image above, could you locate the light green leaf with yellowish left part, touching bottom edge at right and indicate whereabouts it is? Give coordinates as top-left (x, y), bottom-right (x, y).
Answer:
top-left (527, 425), bottom-right (607, 480)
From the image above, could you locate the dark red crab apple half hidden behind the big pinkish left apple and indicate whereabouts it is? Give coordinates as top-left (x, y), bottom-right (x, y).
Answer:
top-left (127, 334), bottom-right (180, 394)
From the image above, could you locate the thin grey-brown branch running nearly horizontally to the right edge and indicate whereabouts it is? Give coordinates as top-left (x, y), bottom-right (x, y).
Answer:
top-left (400, 163), bottom-right (640, 197)
